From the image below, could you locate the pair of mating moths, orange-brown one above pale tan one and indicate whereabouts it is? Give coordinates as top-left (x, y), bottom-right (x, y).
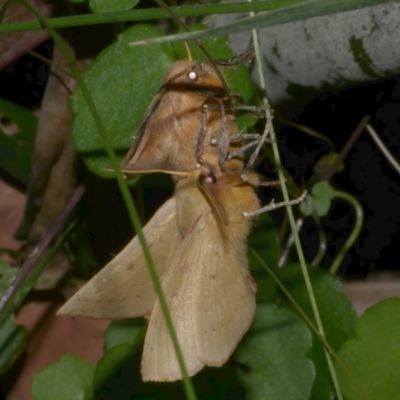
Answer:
top-left (58, 56), bottom-right (268, 381)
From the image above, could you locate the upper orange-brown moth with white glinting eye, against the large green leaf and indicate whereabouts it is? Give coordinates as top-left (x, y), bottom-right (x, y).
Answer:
top-left (122, 60), bottom-right (244, 173)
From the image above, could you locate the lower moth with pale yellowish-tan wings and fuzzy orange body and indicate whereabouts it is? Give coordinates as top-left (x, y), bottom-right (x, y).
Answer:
top-left (58, 153), bottom-right (259, 381)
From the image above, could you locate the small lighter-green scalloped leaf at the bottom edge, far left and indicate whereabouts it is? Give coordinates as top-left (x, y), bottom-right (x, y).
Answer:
top-left (31, 354), bottom-right (95, 400)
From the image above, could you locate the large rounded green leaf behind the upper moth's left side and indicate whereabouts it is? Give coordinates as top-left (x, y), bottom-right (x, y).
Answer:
top-left (72, 25), bottom-right (173, 177)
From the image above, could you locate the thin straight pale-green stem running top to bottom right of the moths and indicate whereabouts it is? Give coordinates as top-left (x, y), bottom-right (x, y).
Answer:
top-left (249, 0), bottom-right (343, 400)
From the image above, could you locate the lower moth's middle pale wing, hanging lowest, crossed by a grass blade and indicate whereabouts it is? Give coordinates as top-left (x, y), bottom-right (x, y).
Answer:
top-left (141, 216), bottom-right (204, 382)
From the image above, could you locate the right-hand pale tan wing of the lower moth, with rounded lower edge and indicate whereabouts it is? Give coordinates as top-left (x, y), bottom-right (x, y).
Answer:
top-left (194, 224), bottom-right (256, 367)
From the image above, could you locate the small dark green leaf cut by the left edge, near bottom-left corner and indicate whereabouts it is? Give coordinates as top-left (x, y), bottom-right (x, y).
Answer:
top-left (0, 318), bottom-right (28, 375)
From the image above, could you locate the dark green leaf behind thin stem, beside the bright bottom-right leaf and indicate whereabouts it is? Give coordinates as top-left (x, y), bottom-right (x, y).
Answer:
top-left (278, 264), bottom-right (357, 400)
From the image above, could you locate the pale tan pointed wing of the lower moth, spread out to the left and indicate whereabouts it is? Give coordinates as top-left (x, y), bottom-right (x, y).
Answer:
top-left (58, 198), bottom-right (181, 319)
